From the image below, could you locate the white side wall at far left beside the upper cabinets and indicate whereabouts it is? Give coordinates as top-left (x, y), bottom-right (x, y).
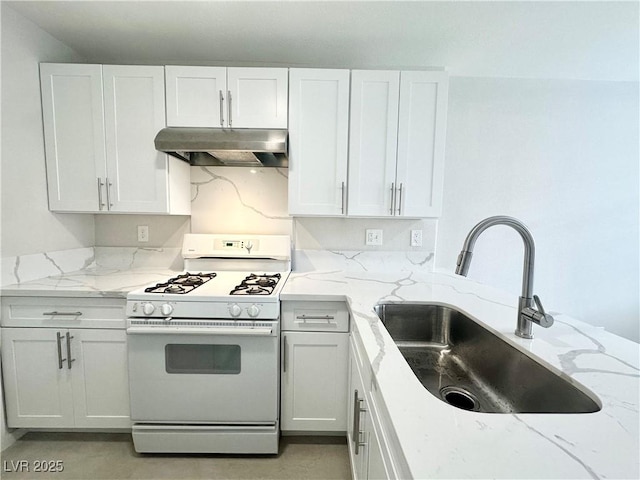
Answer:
top-left (0, 4), bottom-right (89, 449)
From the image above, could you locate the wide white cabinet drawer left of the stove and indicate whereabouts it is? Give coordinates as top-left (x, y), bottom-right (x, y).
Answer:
top-left (2, 297), bottom-right (126, 328)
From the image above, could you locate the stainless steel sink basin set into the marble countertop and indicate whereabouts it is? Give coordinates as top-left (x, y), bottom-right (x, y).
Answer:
top-left (374, 302), bottom-right (602, 413)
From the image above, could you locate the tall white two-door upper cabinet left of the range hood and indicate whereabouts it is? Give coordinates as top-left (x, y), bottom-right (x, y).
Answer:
top-left (40, 64), bottom-right (190, 215)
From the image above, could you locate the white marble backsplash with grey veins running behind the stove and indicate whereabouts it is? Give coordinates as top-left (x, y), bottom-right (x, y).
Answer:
top-left (0, 167), bottom-right (437, 285)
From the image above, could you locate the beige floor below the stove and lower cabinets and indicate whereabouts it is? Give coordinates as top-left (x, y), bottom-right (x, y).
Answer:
top-left (0, 432), bottom-right (351, 480)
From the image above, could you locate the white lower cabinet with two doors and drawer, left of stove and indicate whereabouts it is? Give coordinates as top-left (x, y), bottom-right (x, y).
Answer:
top-left (1, 299), bottom-right (131, 429)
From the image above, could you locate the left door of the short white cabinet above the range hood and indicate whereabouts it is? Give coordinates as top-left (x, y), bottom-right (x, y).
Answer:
top-left (165, 65), bottom-right (227, 128)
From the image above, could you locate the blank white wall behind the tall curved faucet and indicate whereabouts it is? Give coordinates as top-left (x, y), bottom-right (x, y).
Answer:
top-left (436, 77), bottom-right (640, 341)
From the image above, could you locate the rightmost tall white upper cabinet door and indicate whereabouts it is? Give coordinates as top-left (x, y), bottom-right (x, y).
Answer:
top-left (396, 72), bottom-right (448, 217)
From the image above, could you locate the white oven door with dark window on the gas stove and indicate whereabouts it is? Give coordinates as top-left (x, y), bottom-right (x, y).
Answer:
top-left (127, 322), bottom-right (279, 425)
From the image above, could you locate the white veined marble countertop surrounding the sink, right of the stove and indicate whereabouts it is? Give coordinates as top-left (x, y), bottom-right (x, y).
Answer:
top-left (280, 269), bottom-right (640, 479)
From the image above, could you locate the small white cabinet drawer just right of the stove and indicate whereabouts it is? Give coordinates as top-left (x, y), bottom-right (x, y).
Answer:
top-left (282, 302), bottom-right (349, 332)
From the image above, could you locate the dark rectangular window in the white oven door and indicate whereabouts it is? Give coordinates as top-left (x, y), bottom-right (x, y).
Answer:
top-left (164, 344), bottom-right (240, 375)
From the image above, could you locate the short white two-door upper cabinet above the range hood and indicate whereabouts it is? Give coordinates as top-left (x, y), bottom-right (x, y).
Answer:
top-left (165, 65), bottom-right (288, 128)
